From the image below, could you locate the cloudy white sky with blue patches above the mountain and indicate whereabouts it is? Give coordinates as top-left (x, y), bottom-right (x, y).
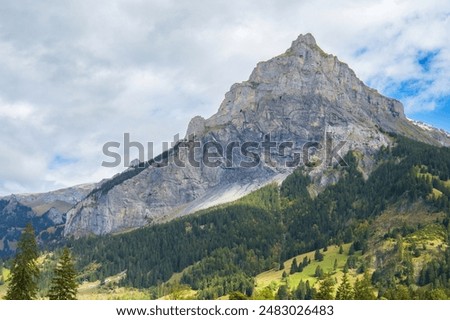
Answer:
top-left (0, 0), bottom-right (450, 195)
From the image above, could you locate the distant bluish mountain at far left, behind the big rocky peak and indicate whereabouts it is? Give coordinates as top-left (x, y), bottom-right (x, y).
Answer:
top-left (0, 184), bottom-right (94, 257)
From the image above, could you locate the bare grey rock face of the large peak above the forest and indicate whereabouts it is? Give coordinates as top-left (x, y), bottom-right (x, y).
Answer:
top-left (65, 34), bottom-right (450, 237)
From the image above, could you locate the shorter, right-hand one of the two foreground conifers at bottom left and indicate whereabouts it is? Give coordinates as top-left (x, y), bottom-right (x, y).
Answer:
top-left (48, 247), bottom-right (78, 300)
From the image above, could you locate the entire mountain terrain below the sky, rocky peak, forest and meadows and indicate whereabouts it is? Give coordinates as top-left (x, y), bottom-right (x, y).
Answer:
top-left (0, 34), bottom-right (450, 300)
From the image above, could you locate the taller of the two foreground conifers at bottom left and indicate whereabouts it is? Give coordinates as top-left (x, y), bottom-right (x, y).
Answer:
top-left (5, 224), bottom-right (39, 300)
